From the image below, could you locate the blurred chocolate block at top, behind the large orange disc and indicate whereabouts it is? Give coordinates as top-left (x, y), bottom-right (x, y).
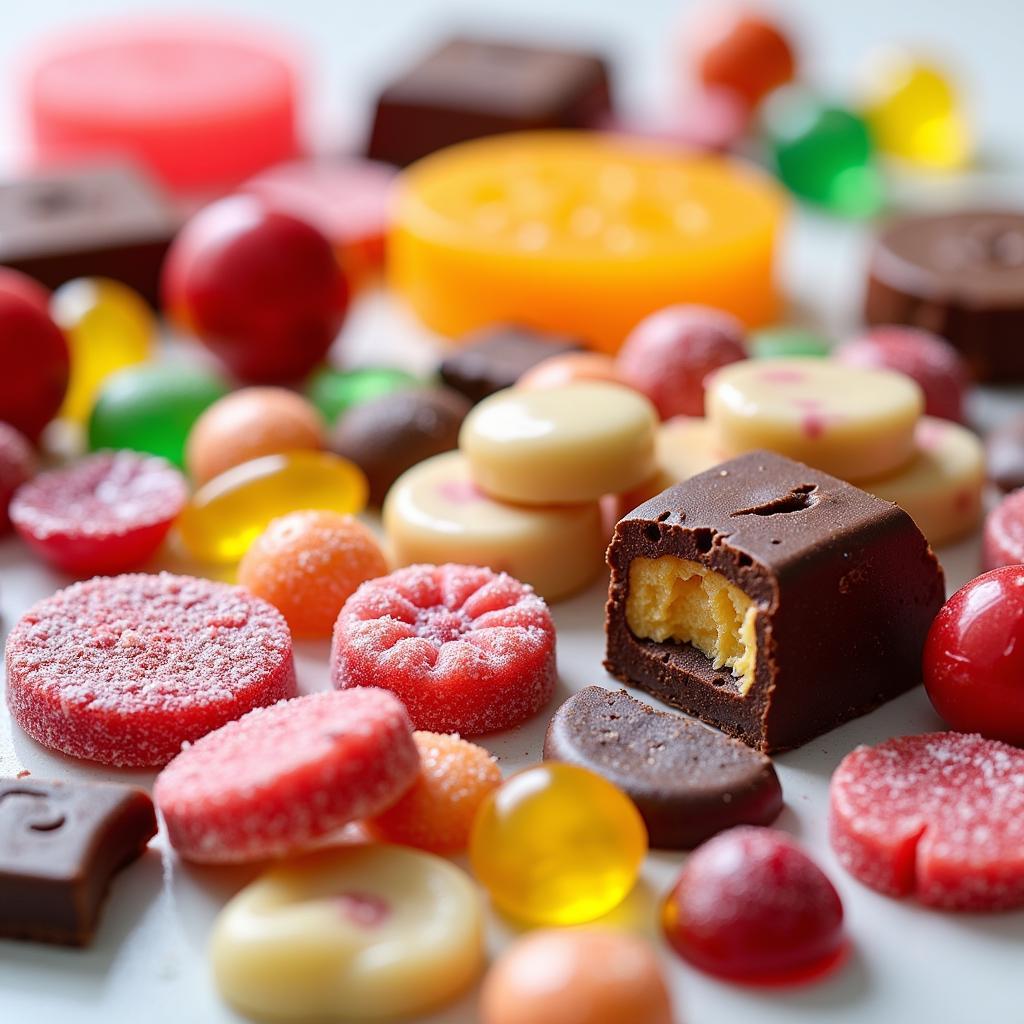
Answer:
top-left (367, 39), bottom-right (610, 167)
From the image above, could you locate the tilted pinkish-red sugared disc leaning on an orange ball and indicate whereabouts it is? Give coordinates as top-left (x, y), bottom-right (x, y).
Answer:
top-left (154, 688), bottom-right (420, 864)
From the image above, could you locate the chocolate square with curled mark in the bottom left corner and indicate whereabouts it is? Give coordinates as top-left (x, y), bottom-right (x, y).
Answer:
top-left (0, 778), bottom-right (157, 946)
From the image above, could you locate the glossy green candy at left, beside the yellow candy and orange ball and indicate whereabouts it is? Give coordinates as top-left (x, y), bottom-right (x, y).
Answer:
top-left (89, 362), bottom-right (230, 466)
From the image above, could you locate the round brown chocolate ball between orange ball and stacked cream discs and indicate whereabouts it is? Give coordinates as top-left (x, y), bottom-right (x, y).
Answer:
top-left (331, 387), bottom-right (470, 505)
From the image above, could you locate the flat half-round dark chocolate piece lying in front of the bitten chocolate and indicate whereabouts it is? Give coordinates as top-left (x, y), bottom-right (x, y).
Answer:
top-left (544, 686), bottom-right (782, 850)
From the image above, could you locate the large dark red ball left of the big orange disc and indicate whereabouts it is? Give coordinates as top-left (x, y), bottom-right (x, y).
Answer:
top-left (162, 196), bottom-right (348, 383)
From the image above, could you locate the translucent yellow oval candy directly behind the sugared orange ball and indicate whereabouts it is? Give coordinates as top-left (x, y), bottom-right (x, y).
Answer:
top-left (178, 452), bottom-right (368, 564)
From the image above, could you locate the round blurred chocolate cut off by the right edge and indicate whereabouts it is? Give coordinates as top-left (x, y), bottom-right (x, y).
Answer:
top-left (864, 210), bottom-right (1024, 381)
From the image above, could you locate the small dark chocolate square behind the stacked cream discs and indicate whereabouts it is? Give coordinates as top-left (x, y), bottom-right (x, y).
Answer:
top-left (440, 325), bottom-right (583, 402)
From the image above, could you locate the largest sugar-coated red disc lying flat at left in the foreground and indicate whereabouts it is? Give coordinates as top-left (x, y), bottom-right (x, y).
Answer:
top-left (6, 572), bottom-right (295, 768)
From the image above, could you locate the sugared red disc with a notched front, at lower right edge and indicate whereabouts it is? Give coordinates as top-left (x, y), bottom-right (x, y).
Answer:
top-left (829, 732), bottom-right (1024, 910)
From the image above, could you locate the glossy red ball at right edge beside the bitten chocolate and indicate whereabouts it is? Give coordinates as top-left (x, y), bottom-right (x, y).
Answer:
top-left (924, 565), bottom-right (1024, 746)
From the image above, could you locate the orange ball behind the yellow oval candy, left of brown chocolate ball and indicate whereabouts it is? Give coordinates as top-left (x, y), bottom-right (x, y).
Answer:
top-left (185, 387), bottom-right (325, 484)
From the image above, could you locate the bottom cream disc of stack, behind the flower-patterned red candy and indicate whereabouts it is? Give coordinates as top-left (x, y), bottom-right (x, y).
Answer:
top-left (383, 452), bottom-right (607, 601)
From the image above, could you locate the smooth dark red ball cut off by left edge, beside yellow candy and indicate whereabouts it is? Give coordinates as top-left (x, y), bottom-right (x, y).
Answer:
top-left (0, 288), bottom-right (71, 440)
